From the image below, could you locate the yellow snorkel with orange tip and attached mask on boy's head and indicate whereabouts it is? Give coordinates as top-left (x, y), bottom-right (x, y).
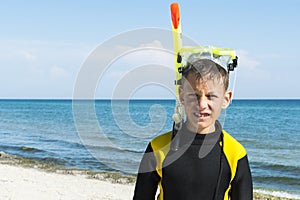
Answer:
top-left (170, 3), bottom-right (238, 151)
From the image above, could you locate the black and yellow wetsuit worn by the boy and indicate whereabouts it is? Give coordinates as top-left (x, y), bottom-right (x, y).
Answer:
top-left (133, 123), bottom-right (253, 200)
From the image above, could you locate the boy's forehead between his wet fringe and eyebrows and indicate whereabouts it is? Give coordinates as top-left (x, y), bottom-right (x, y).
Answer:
top-left (182, 73), bottom-right (224, 92)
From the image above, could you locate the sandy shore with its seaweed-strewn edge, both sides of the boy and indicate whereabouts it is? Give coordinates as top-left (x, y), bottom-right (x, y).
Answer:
top-left (0, 152), bottom-right (296, 200)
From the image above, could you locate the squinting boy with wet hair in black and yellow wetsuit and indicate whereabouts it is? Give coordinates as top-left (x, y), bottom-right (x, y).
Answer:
top-left (133, 58), bottom-right (253, 200)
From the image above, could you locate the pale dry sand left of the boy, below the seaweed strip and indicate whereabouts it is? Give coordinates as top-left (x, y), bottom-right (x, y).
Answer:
top-left (0, 164), bottom-right (134, 200)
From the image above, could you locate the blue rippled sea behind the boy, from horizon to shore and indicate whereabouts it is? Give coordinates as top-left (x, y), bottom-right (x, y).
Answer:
top-left (0, 99), bottom-right (300, 199)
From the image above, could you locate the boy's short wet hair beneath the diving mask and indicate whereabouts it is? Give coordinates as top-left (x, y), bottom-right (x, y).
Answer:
top-left (181, 59), bottom-right (229, 91)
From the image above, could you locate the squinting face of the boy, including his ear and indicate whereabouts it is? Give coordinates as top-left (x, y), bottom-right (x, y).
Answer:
top-left (179, 73), bottom-right (232, 134)
